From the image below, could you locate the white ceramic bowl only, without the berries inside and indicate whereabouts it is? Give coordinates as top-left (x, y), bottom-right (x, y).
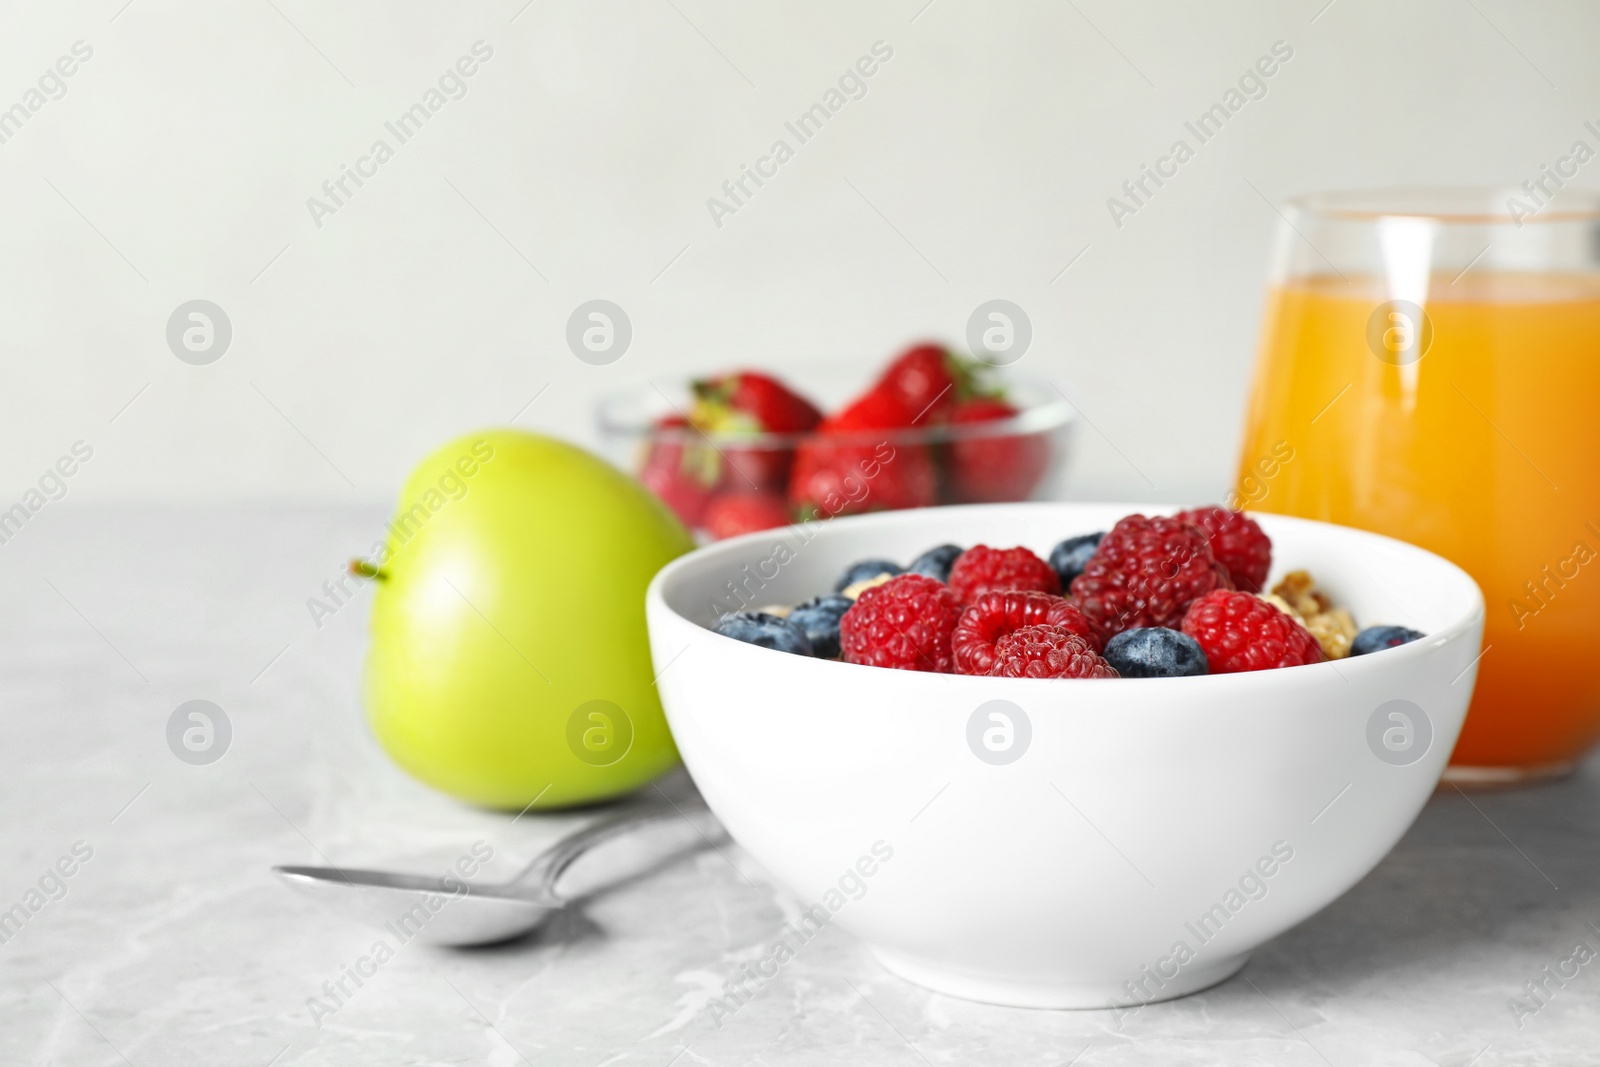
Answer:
top-left (648, 504), bottom-right (1483, 1008)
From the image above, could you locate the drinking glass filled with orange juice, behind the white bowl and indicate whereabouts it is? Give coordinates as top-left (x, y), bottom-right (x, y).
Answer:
top-left (1237, 182), bottom-right (1600, 784)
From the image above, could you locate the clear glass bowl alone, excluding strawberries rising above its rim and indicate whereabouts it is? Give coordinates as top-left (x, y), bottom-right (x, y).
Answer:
top-left (598, 371), bottom-right (1075, 541)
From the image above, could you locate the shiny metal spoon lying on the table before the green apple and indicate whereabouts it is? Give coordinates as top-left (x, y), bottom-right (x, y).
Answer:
top-left (272, 806), bottom-right (706, 945)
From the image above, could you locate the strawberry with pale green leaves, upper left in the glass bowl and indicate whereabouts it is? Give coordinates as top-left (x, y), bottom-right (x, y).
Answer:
top-left (693, 371), bottom-right (822, 493)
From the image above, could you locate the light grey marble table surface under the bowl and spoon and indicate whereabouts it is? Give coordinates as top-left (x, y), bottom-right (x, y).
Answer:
top-left (0, 502), bottom-right (1600, 1067)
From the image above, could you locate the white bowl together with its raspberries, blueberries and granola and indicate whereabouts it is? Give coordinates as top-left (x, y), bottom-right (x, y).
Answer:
top-left (646, 502), bottom-right (1483, 1013)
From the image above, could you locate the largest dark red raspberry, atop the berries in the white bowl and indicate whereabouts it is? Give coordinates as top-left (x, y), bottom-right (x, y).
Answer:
top-left (1072, 515), bottom-right (1232, 638)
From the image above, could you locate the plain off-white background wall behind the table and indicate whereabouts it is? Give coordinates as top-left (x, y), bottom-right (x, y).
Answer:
top-left (0, 0), bottom-right (1600, 502)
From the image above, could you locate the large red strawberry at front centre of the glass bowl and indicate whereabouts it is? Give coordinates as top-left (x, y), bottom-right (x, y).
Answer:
top-left (789, 390), bottom-right (938, 518)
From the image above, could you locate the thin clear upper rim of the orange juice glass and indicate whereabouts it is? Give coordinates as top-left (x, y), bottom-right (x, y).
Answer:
top-left (1286, 186), bottom-right (1600, 227)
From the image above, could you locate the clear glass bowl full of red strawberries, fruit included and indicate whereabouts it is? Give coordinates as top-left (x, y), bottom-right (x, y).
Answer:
top-left (600, 344), bottom-right (1074, 541)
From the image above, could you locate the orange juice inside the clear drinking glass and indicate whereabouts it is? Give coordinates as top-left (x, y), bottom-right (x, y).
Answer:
top-left (1238, 272), bottom-right (1600, 779)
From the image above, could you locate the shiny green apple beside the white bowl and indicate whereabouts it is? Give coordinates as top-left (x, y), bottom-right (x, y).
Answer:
top-left (355, 430), bottom-right (694, 809)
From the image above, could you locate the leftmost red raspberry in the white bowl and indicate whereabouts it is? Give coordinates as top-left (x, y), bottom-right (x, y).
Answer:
top-left (838, 574), bottom-right (962, 673)
